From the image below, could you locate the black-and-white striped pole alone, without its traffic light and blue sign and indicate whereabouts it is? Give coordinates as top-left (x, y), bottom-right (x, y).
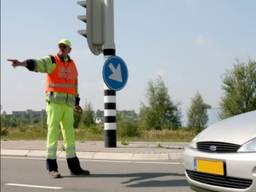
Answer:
top-left (103, 0), bottom-right (116, 147)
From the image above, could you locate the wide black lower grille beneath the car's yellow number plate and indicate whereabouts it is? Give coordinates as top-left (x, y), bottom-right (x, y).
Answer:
top-left (186, 170), bottom-right (252, 189)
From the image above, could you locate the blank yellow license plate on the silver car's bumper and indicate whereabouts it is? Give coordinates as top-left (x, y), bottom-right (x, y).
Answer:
top-left (196, 159), bottom-right (225, 175)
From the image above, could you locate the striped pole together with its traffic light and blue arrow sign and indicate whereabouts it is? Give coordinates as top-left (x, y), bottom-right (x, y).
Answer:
top-left (78, 0), bottom-right (128, 147)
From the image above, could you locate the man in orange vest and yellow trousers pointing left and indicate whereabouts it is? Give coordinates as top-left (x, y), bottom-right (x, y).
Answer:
top-left (8, 39), bottom-right (90, 178)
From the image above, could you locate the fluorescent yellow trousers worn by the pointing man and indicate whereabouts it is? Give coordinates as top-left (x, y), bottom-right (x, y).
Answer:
top-left (46, 102), bottom-right (76, 159)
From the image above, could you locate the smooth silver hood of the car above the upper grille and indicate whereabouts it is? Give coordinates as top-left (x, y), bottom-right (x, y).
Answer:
top-left (196, 111), bottom-right (256, 145)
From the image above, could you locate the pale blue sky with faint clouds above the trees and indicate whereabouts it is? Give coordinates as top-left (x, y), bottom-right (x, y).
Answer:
top-left (1, 0), bottom-right (256, 123)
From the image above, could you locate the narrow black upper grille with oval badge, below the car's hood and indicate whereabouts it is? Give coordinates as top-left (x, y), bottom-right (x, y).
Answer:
top-left (197, 141), bottom-right (240, 153)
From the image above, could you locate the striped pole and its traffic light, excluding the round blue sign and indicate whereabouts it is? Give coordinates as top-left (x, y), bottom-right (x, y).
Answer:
top-left (78, 0), bottom-right (116, 147)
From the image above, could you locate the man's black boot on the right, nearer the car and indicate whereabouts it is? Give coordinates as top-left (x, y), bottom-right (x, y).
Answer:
top-left (67, 157), bottom-right (90, 175)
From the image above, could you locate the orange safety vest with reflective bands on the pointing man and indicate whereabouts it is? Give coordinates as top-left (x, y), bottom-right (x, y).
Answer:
top-left (46, 55), bottom-right (78, 95)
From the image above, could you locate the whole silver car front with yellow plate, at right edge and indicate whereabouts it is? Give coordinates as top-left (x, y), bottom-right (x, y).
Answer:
top-left (184, 111), bottom-right (256, 192)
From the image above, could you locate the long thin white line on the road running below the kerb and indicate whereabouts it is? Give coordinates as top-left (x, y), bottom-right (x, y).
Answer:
top-left (1, 156), bottom-right (184, 165)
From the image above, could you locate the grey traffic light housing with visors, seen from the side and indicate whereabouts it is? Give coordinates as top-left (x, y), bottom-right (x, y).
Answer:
top-left (78, 0), bottom-right (104, 55)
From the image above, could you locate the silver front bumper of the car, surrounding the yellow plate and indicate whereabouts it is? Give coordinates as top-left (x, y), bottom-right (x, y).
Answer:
top-left (184, 148), bottom-right (256, 192)
